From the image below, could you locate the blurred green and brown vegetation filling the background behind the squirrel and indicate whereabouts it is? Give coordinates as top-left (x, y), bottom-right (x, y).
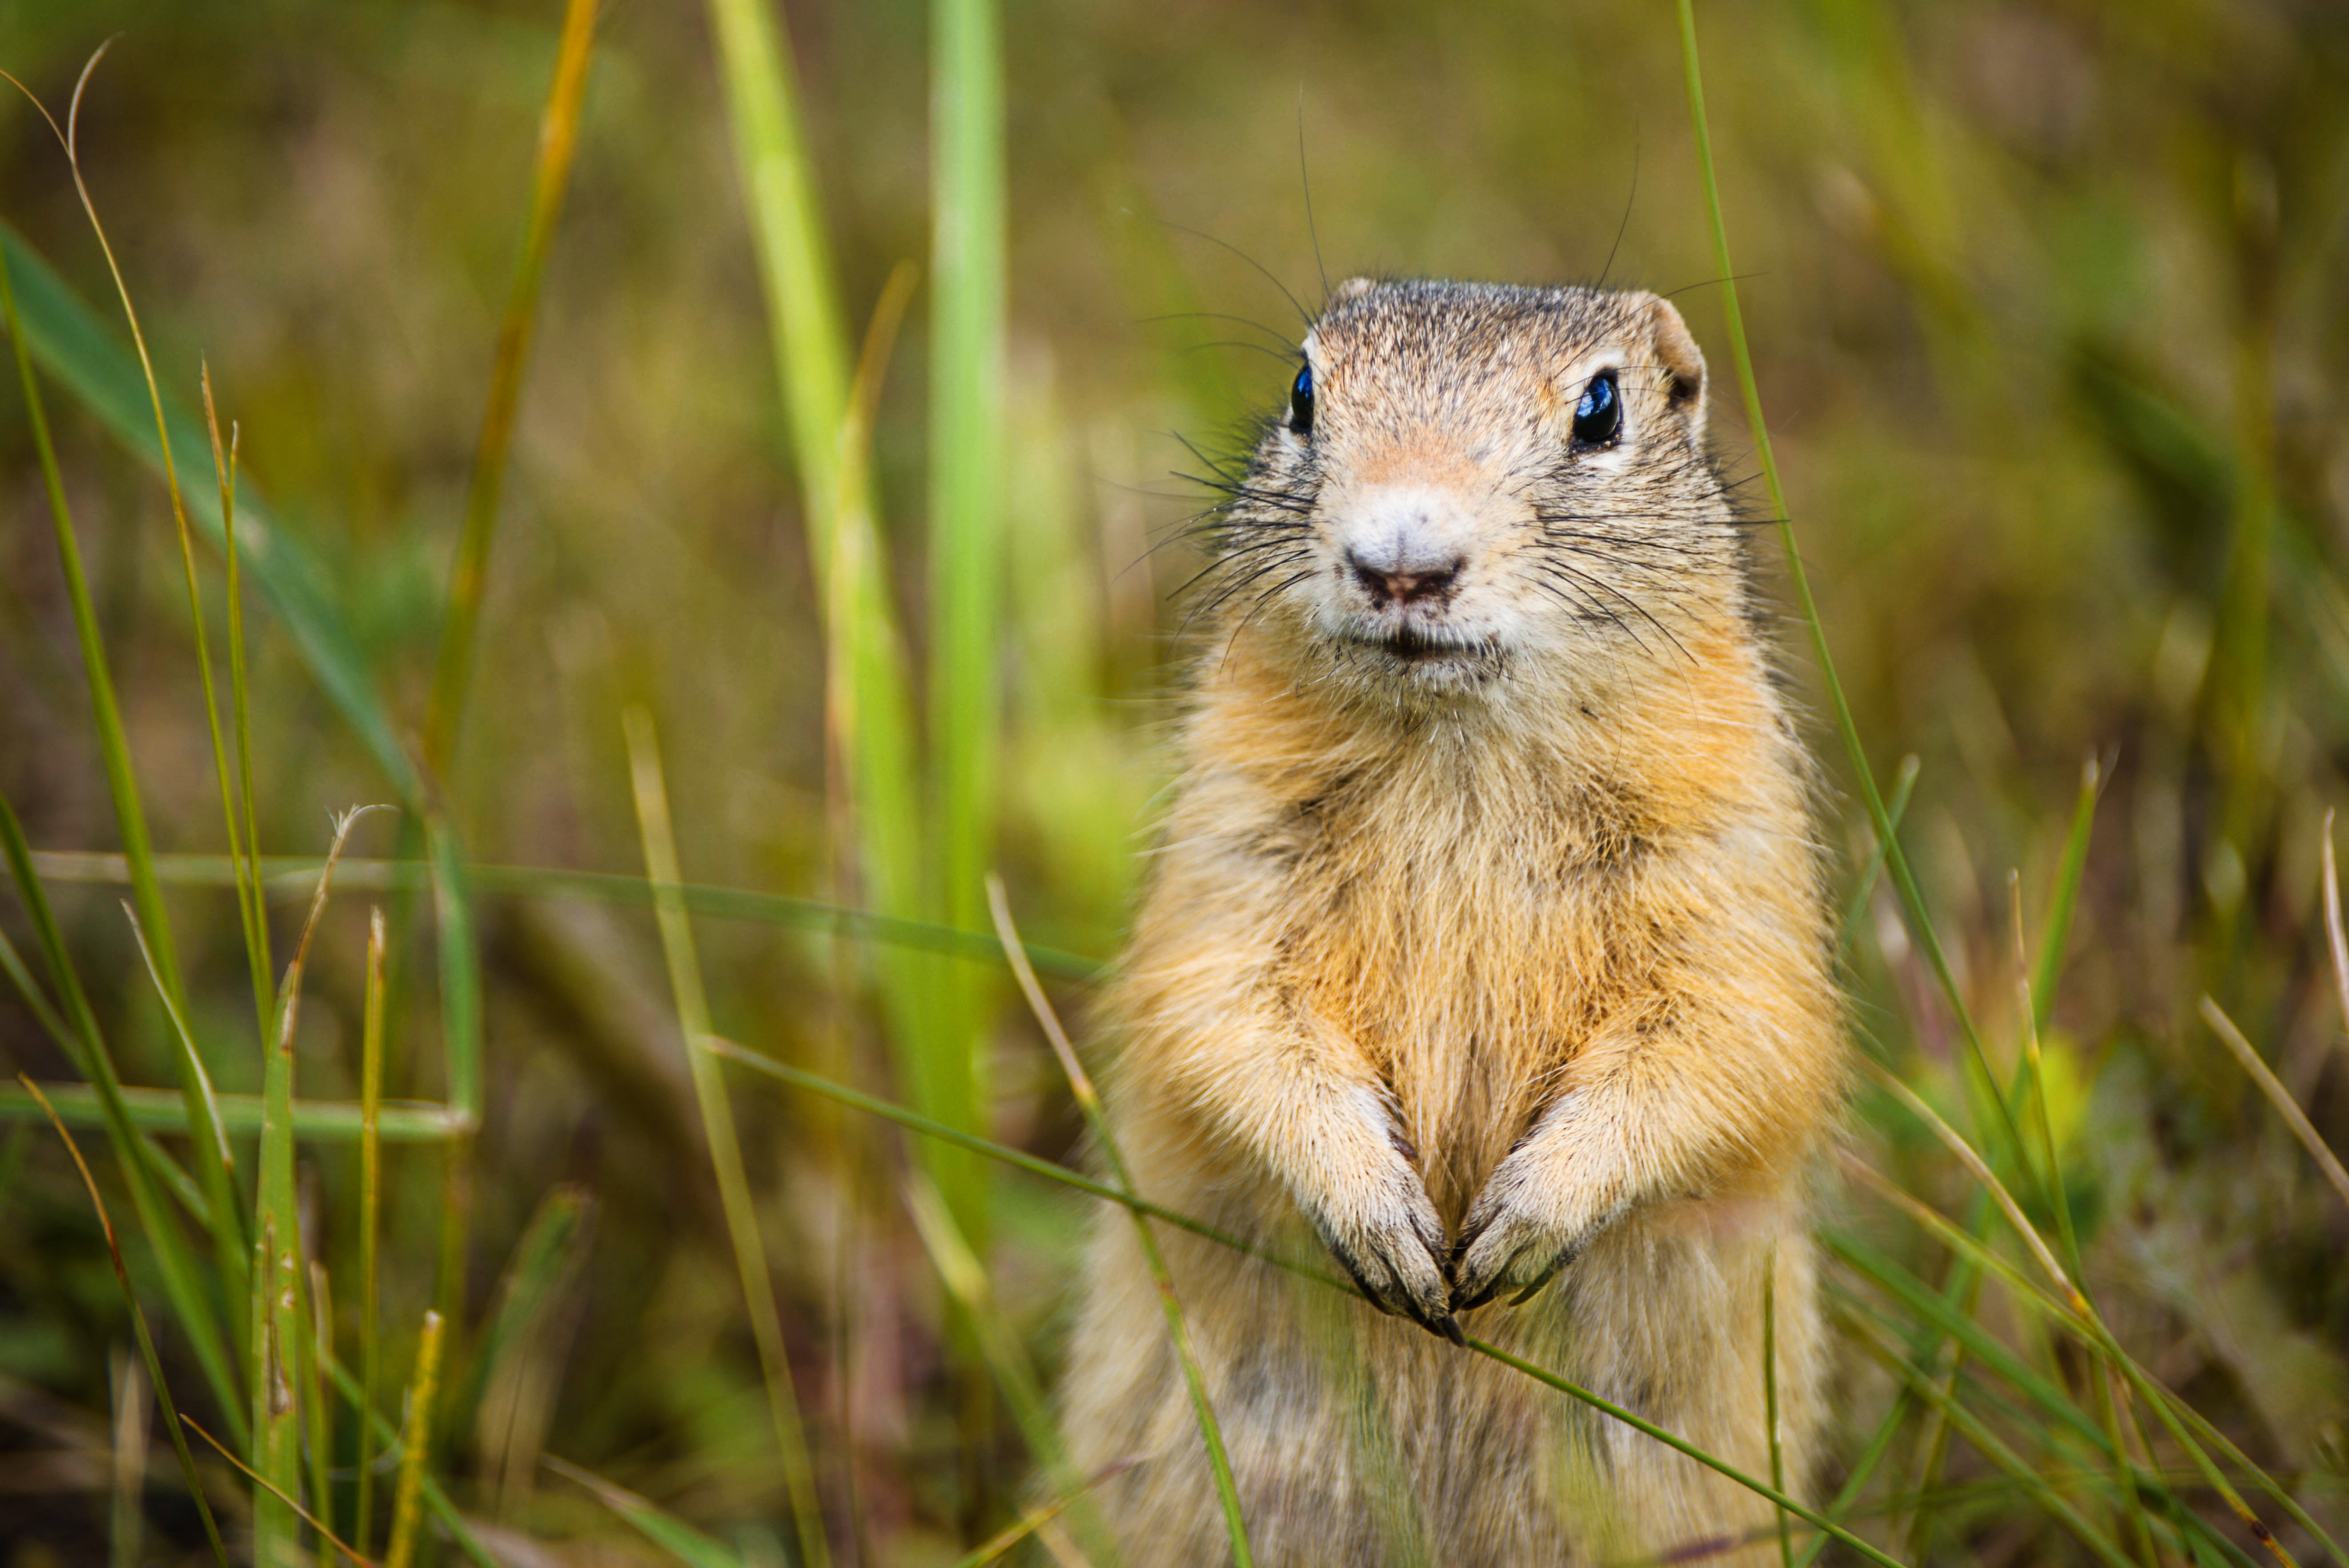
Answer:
top-left (0, 0), bottom-right (2349, 1568)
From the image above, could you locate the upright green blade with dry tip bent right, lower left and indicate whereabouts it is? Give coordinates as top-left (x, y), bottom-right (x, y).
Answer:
top-left (249, 805), bottom-right (380, 1568)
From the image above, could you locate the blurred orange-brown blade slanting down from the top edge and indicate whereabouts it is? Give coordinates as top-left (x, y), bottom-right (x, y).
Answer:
top-left (423, 0), bottom-right (596, 779)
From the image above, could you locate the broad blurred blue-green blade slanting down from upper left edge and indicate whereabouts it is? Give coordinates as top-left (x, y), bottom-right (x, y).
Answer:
top-left (0, 220), bottom-right (418, 803)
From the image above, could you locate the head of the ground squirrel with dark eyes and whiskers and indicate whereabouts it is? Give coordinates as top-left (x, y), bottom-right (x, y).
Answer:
top-left (1214, 279), bottom-right (1741, 697)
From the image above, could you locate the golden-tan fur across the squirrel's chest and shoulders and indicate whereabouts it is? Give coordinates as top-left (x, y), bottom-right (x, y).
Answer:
top-left (1116, 636), bottom-right (1825, 1225)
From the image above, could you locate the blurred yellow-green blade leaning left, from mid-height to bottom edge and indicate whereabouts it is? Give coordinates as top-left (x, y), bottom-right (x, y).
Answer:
top-left (623, 707), bottom-right (832, 1568)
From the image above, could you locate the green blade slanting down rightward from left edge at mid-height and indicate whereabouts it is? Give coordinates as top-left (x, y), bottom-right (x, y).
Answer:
top-left (0, 796), bottom-right (244, 1434)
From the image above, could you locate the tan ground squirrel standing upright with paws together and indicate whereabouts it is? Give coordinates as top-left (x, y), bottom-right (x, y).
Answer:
top-left (1064, 279), bottom-right (1841, 1568)
